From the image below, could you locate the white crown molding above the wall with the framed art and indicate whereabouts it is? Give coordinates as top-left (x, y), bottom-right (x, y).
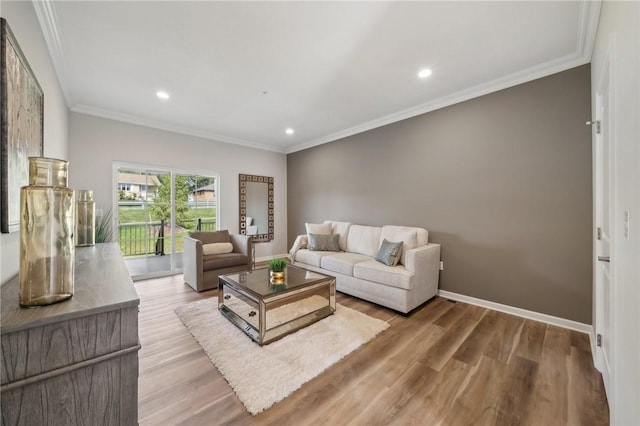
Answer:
top-left (32, 0), bottom-right (73, 108)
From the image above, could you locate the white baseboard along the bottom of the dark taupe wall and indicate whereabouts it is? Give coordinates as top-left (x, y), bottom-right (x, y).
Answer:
top-left (438, 290), bottom-right (595, 336)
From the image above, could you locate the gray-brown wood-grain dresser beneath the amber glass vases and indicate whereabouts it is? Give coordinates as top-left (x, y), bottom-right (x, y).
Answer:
top-left (0, 243), bottom-right (140, 426)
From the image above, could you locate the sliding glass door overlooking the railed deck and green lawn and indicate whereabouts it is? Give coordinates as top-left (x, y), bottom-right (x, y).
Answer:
top-left (114, 163), bottom-right (218, 279)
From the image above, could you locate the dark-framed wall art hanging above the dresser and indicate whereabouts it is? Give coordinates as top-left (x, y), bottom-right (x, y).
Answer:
top-left (0, 18), bottom-right (44, 233)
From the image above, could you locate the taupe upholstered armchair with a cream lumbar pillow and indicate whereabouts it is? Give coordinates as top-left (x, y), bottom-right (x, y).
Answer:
top-left (182, 230), bottom-right (252, 291)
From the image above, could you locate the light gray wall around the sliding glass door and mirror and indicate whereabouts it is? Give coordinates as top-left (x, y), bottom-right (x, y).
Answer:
top-left (69, 112), bottom-right (287, 260)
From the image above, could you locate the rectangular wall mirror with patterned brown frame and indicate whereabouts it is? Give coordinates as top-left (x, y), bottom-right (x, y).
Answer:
top-left (240, 174), bottom-right (273, 242)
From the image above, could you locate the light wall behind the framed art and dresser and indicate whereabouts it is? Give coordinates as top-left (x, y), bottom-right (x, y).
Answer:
top-left (0, 0), bottom-right (69, 283)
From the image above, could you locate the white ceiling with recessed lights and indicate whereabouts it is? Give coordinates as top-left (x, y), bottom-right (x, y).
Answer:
top-left (34, 0), bottom-right (600, 153)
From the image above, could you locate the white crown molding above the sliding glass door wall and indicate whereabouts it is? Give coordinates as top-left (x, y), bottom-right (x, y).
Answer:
top-left (71, 104), bottom-right (284, 154)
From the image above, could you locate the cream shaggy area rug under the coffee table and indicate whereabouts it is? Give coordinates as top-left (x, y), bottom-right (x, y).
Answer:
top-left (175, 298), bottom-right (389, 415)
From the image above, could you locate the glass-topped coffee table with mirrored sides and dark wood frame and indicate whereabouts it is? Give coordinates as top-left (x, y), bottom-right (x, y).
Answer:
top-left (218, 266), bottom-right (336, 346)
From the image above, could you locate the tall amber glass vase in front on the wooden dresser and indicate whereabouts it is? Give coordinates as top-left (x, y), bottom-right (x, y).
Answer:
top-left (20, 157), bottom-right (75, 307)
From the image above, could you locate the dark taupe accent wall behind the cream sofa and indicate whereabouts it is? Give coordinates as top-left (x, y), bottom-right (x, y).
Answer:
top-left (287, 65), bottom-right (592, 324)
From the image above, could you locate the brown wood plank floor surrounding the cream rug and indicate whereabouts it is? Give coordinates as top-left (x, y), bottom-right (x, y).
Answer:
top-left (135, 275), bottom-right (609, 426)
